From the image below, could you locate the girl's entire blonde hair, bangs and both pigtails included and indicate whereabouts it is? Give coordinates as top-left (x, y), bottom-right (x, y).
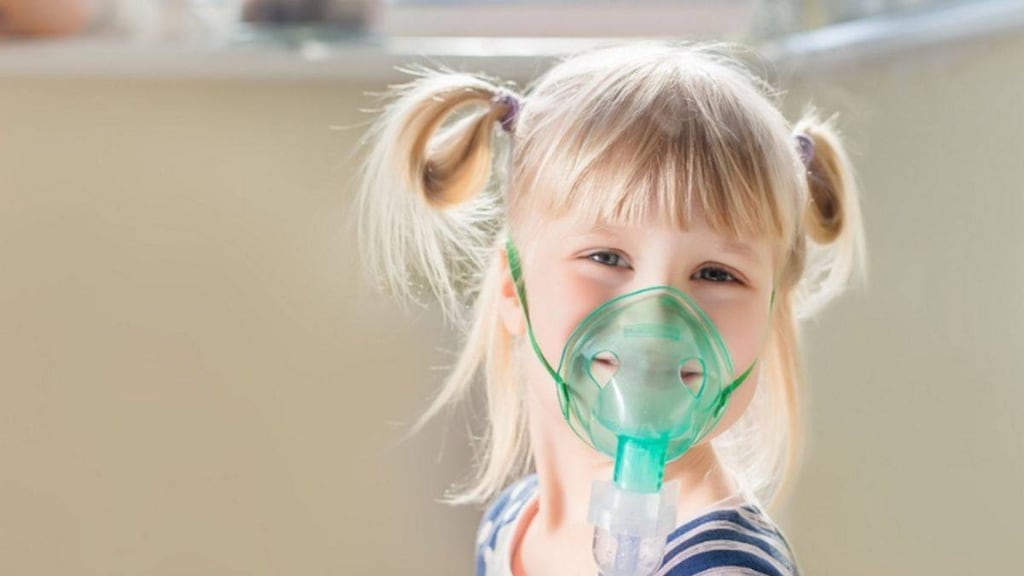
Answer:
top-left (357, 41), bottom-right (865, 506)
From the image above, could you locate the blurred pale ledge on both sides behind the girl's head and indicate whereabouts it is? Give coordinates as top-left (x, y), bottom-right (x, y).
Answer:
top-left (0, 0), bottom-right (1024, 83)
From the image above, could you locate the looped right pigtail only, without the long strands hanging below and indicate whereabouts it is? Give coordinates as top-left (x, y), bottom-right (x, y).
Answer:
top-left (795, 107), bottom-right (866, 319)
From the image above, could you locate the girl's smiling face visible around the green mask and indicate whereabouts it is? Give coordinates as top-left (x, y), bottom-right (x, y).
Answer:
top-left (502, 206), bottom-right (774, 442)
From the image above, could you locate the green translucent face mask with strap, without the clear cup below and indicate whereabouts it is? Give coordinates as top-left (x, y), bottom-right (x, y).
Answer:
top-left (506, 239), bottom-right (774, 493)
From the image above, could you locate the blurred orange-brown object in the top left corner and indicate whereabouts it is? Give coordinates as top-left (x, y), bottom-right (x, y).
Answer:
top-left (0, 0), bottom-right (96, 37)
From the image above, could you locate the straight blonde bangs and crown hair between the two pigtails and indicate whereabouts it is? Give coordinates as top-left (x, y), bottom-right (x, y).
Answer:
top-left (511, 46), bottom-right (801, 245)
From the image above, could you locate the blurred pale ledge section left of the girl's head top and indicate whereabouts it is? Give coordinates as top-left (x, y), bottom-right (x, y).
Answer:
top-left (0, 37), bottom-right (608, 81)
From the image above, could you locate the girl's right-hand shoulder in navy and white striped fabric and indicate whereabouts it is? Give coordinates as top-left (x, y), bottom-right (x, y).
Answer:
top-left (656, 503), bottom-right (800, 576)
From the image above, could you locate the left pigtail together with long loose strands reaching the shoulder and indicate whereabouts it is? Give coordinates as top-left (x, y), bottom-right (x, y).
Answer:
top-left (356, 63), bottom-right (527, 504)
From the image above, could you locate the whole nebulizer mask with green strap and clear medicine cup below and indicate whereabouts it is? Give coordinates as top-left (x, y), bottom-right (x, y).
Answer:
top-left (506, 238), bottom-right (774, 576)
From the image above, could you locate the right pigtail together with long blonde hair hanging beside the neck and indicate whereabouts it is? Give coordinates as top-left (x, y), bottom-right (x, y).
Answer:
top-left (733, 107), bottom-right (865, 508)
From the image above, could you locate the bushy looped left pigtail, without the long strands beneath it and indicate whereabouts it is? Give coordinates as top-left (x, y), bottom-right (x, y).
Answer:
top-left (357, 69), bottom-right (524, 324)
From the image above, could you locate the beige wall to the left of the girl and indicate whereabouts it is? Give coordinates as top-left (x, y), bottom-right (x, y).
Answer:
top-left (0, 79), bottom-right (475, 575)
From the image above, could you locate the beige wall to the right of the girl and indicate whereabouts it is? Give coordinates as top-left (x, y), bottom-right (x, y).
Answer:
top-left (774, 30), bottom-right (1024, 575)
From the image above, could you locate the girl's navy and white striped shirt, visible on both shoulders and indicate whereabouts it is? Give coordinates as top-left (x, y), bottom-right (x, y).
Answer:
top-left (476, 474), bottom-right (800, 576)
